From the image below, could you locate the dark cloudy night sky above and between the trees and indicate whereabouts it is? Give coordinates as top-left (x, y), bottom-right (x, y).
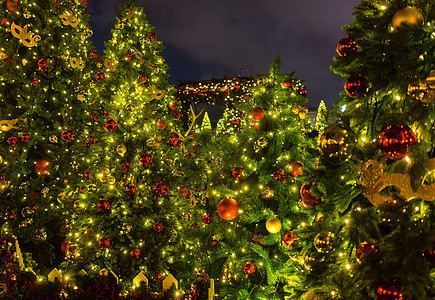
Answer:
top-left (87, 0), bottom-right (360, 107)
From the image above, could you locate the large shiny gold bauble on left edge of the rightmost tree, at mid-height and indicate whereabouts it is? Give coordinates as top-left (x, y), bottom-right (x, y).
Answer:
top-left (317, 124), bottom-right (350, 163)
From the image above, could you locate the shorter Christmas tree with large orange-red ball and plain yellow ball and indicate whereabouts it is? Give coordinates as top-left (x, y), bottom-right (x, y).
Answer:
top-left (189, 59), bottom-right (314, 299)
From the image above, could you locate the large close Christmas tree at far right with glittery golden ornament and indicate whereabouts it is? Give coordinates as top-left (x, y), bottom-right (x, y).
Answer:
top-left (289, 0), bottom-right (435, 300)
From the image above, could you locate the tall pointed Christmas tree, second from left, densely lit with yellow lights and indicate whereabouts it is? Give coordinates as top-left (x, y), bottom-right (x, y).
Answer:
top-left (63, 2), bottom-right (194, 291)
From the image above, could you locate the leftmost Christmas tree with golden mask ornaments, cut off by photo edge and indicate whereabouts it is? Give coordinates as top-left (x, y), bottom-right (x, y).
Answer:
top-left (0, 0), bottom-right (96, 274)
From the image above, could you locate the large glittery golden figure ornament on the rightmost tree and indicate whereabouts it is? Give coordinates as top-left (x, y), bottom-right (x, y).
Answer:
top-left (360, 158), bottom-right (435, 207)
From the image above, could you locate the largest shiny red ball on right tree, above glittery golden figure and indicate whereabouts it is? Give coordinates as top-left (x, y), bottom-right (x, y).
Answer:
top-left (379, 125), bottom-right (417, 160)
